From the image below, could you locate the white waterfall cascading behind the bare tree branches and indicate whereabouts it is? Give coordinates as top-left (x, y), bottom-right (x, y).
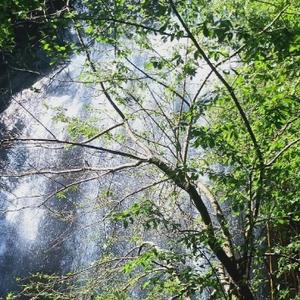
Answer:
top-left (0, 34), bottom-right (216, 295)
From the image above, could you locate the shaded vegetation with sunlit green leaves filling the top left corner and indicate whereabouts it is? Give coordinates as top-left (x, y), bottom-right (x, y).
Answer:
top-left (0, 0), bottom-right (65, 112)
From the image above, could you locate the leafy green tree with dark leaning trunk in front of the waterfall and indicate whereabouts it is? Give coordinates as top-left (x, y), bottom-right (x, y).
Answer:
top-left (2, 0), bottom-right (300, 299)
